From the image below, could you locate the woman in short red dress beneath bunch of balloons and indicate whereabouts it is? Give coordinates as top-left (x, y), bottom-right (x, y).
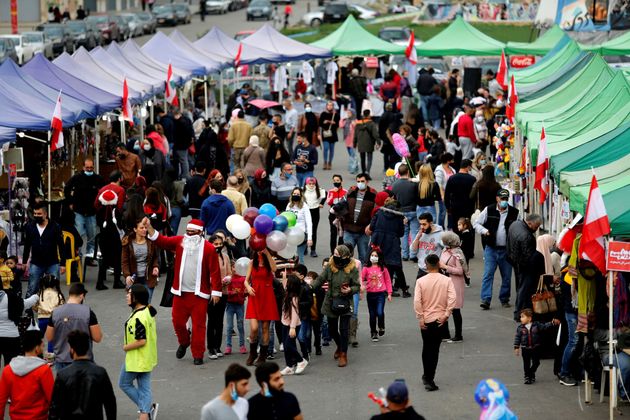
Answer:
top-left (245, 249), bottom-right (280, 366)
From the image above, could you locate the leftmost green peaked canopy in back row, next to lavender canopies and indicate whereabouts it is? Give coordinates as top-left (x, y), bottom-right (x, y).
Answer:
top-left (311, 15), bottom-right (405, 55)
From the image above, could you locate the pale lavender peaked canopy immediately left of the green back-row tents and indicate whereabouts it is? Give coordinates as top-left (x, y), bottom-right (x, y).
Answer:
top-left (243, 23), bottom-right (332, 61)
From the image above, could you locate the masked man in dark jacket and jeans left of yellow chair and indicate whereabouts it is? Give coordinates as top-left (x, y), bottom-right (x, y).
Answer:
top-left (22, 202), bottom-right (66, 297)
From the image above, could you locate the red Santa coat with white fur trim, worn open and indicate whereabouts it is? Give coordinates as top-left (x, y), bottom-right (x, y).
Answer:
top-left (149, 232), bottom-right (223, 299)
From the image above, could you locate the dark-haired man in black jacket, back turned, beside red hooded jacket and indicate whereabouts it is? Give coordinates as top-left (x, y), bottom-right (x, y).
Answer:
top-left (49, 330), bottom-right (116, 420)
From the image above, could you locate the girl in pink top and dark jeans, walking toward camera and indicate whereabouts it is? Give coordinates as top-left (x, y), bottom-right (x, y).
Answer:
top-left (361, 247), bottom-right (392, 342)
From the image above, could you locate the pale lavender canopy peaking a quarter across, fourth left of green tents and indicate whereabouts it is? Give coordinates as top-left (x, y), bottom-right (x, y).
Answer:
top-left (142, 32), bottom-right (214, 76)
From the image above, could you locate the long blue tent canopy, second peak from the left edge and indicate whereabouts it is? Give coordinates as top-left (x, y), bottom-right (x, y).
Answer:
top-left (22, 53), bottom-right (121, 115)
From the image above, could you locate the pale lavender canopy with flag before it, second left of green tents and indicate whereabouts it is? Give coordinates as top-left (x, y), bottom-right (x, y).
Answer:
top-left (192, 26), bottom-right (280, 64)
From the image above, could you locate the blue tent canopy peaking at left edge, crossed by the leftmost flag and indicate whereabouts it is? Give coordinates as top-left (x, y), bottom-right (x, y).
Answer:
top-left (0, 60), bottom-right (91, 127)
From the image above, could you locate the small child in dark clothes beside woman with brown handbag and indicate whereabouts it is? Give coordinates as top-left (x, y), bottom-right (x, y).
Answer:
top-left (514, 309), bottom-right (560, 385)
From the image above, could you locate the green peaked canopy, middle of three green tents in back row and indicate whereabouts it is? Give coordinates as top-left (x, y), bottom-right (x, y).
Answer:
top-left (416, 16), bottom-right (505, 57)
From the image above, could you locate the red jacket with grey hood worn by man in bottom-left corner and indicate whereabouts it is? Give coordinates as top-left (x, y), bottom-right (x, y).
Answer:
top-left (0, 356), bottom-right (55, 420)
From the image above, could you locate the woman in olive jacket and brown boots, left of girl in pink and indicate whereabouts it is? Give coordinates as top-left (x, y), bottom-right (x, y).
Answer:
top-left (311, 245), bottom-right (361, 367)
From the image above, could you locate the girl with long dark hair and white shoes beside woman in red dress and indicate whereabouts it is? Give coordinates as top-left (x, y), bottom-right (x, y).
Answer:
top-left (280, 274), bottom-right (308, 375)
